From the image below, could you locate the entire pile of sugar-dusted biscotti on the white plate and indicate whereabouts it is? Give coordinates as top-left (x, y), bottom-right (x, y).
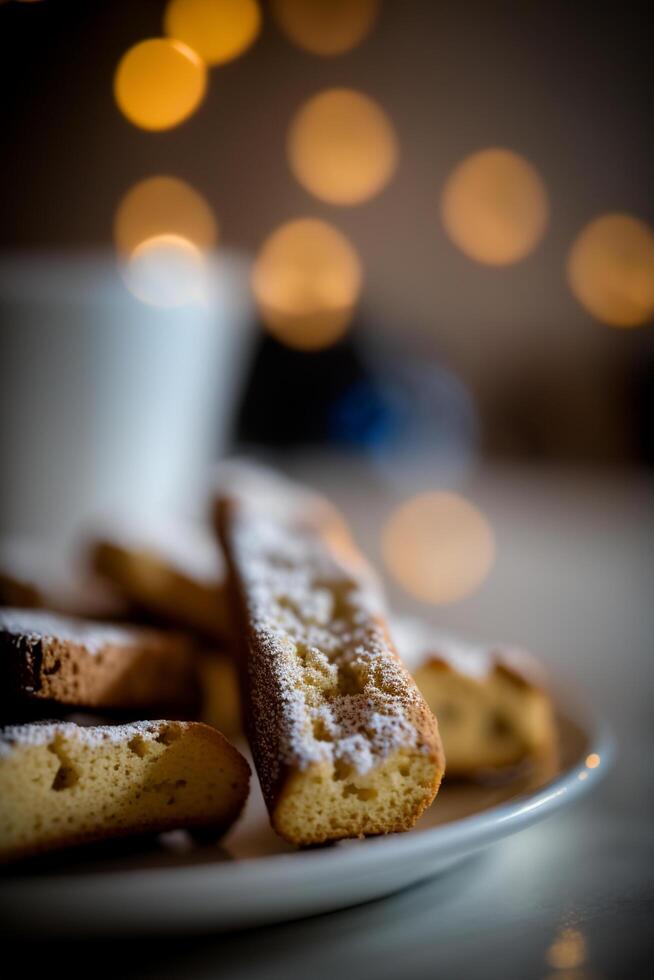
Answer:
top-left (0, 464), bottom-right (555, 860)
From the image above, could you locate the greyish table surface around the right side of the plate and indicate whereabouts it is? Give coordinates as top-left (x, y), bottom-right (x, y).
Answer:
top-left (6, 458), bottom-right (654, 980)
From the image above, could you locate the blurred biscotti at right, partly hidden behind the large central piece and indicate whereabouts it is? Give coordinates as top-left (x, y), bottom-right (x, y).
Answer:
top-left (391, 619), bottom-right (556, 776)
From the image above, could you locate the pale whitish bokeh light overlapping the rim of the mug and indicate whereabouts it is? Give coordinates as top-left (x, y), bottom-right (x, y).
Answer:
top-left (123, 235), bottom-right (207, 307)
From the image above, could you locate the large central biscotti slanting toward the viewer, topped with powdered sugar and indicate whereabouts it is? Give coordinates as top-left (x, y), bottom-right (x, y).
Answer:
top-left (216, 470), bottom-right (443, 844)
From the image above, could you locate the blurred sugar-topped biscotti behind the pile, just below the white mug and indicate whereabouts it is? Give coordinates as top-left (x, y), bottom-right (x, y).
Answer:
top-left (89, 521), bottom-right (230, 640)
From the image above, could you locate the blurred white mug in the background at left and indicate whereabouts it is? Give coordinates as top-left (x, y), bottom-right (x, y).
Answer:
top-left (0, 251), bottom-right (253, 555)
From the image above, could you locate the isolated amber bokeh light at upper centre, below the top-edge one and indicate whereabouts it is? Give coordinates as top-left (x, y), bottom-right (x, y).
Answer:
top-left (287, 89), bottom-right (398, 204)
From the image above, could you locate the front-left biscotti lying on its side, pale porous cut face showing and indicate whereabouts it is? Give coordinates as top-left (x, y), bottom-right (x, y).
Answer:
top-left (0, 721), bottom-right (250, 861)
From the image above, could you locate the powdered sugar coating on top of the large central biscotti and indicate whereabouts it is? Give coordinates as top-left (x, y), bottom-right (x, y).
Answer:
top-left (229, 506), bottom-right (420, 782)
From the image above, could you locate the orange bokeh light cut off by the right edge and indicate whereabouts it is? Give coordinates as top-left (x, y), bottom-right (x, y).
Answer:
top-left (568, 214), bottom-right (654, 327)
